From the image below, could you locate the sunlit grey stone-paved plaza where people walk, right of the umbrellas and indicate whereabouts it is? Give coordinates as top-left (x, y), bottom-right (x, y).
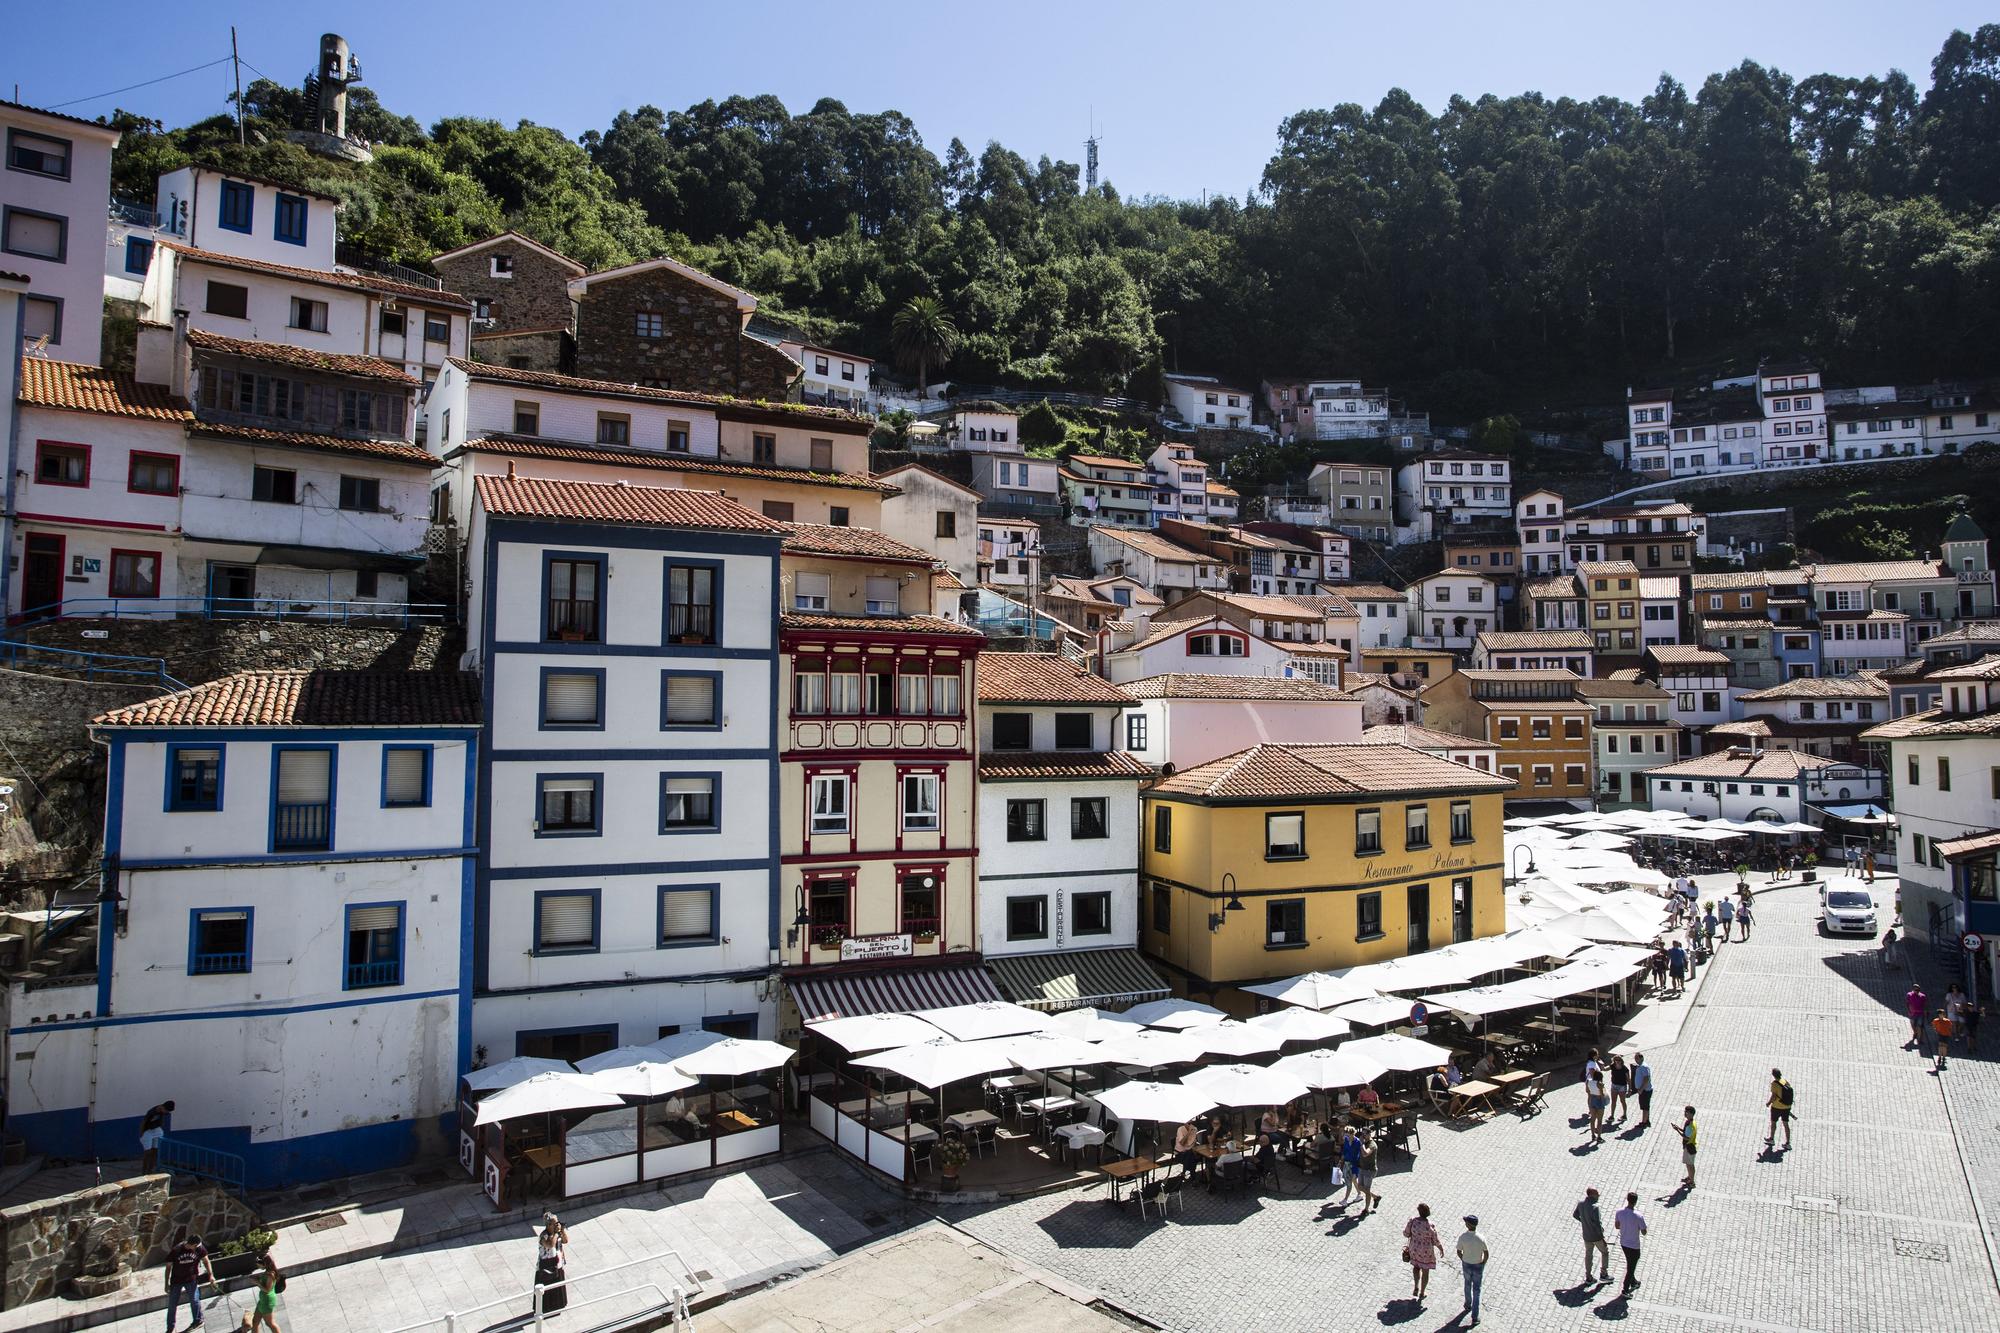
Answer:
top-left (944, 881), bottom-right (2000, 1333)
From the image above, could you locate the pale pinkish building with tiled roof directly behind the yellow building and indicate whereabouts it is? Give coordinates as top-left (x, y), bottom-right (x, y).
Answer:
top-left (1122, 669), bottom-right (1362, 769)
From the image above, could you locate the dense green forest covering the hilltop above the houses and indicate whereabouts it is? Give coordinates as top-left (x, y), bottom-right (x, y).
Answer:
top-left (101, 24), bottom-right (2000, 420)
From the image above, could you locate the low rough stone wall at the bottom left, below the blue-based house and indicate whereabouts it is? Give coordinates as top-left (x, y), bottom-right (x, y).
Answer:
top-left (0, 1175), bottom-right (258, 1309)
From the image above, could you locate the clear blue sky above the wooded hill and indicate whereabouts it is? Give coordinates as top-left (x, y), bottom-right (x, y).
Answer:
top-left (0, 0), bottom-right (1994, 196)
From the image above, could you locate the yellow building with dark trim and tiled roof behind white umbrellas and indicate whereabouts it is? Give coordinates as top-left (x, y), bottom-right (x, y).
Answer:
top-left (1140, 745), bottom-right (1512, 993)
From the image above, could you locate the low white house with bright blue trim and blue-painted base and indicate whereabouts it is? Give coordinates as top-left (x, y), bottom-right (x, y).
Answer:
top-left (6, 671), bottom-right (480, 1189)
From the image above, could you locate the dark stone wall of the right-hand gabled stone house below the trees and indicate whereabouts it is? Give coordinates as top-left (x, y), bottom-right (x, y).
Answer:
top-left (576, 266), bottom-right (800, 400)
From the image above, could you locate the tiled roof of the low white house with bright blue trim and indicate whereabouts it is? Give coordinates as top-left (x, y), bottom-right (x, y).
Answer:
top-left (92, 671), bottom-right (480, 727)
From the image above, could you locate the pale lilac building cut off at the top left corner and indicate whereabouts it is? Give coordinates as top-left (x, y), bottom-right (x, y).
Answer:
top-left (0, 102), bottom-right (120, 366)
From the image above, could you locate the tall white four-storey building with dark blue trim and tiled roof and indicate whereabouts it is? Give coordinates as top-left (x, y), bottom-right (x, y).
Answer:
top-left (466, 476), bottom-right (788, 1061)
